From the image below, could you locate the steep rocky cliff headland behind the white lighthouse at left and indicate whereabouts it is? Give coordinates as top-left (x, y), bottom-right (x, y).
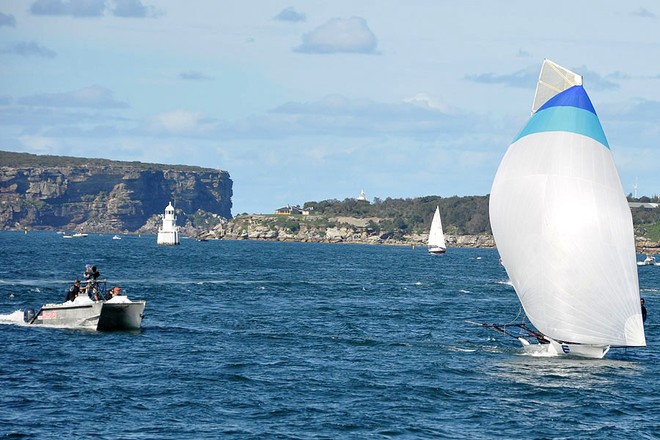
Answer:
top-left (0, 151), bottom-right (232, 232)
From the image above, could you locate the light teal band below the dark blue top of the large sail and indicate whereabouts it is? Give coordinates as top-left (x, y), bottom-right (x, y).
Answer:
top-left (513, 107), bottom-right (610, 149)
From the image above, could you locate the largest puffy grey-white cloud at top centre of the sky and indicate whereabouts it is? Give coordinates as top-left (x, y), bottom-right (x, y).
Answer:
top-left (295, 17), bottom-right (378, 54)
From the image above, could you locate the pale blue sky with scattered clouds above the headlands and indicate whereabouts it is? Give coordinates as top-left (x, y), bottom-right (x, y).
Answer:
top-left (0, 0), bottom-right (660, 215)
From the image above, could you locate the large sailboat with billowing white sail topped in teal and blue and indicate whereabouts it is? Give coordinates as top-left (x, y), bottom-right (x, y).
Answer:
top-left (484, 60), bottom-right (646, 358)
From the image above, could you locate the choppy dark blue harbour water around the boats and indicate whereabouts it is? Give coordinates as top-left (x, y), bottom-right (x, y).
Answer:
top-left (0, 232), bottom-right (660, 439)
